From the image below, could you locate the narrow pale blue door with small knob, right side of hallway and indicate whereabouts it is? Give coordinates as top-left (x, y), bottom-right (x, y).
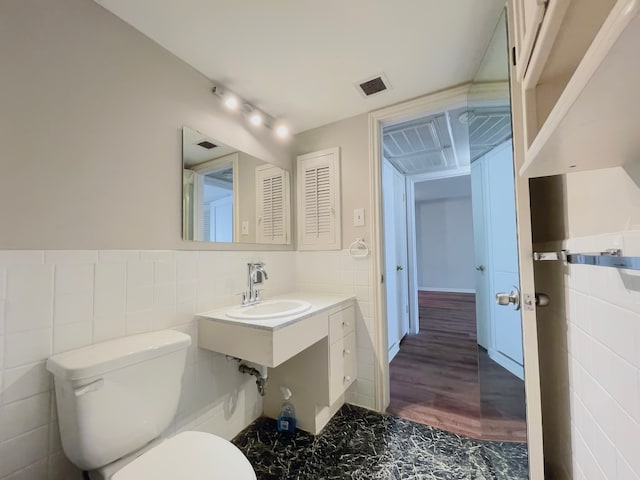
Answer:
top-left (471, 159), bottom-right (492, 351)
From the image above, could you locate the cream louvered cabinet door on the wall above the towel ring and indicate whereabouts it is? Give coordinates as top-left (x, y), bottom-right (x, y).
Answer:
top-left (298, 148), bottom-right (340, 250)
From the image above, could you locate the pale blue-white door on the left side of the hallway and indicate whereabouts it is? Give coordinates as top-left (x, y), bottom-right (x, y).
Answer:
top-left (382, 162), bottom-right (409, 361)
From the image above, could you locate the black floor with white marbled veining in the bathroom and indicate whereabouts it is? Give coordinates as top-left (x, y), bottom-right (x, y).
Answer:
top-left (233, 405), bottom-right (529, 480)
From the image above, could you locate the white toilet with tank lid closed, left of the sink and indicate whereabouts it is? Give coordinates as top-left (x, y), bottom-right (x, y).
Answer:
top-left (47, 330), bottom-right (256, 480)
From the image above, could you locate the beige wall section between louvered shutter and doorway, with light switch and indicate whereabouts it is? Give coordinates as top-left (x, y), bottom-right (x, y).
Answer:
top-left (294, 114), bottom-right (372, 248)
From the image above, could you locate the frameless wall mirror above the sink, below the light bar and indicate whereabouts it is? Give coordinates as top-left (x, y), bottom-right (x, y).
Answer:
top-left (182, 127), bottom-right (291, 245)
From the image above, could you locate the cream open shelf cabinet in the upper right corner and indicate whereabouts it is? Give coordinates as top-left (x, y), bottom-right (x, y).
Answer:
top-left (509, 0), bottom-right (640, 177)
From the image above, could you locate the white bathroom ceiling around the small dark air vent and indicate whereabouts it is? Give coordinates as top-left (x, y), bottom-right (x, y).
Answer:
top-left (96, 0), bottom-right (504, 132)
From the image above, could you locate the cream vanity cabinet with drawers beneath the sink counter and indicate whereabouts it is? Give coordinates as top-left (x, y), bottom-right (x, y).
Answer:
top-left (264, 301), bottom-right (357, 435)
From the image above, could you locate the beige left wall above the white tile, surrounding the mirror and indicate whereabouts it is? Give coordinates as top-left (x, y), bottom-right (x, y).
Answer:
top-left (0, 0), bottom-right (291, 249)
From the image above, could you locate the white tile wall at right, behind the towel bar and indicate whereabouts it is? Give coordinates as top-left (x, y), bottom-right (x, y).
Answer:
top-left (565, 231), bottom-right (640, 480)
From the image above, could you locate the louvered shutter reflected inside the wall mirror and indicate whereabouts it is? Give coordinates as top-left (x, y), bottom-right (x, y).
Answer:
top-left (256, 166), bottom-right (290, 244)
